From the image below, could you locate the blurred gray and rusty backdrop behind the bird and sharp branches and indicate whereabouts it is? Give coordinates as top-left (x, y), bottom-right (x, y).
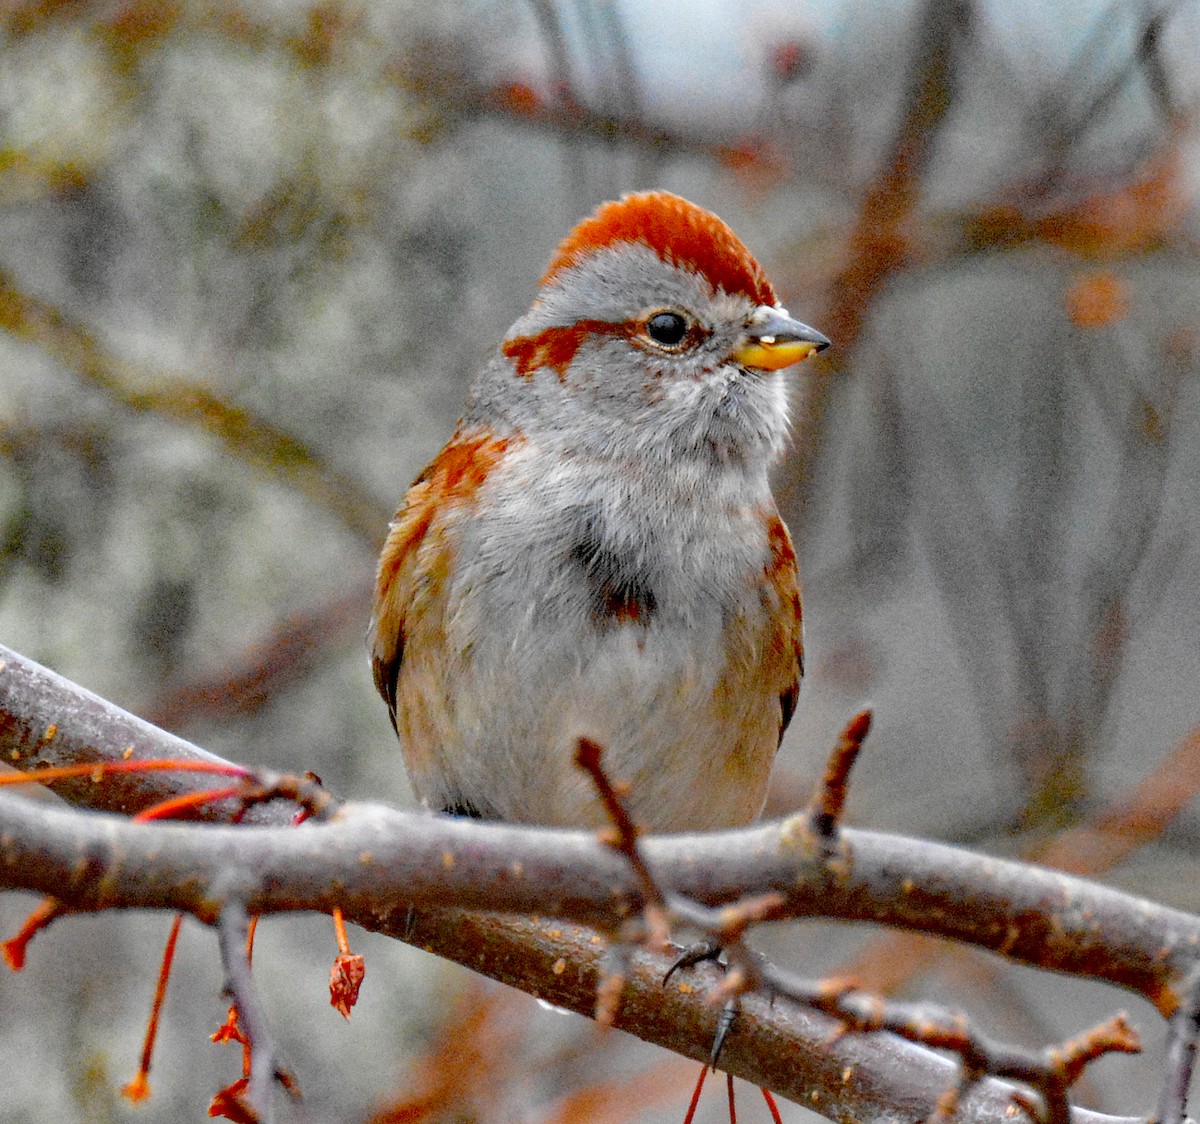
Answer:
top-left (0, 0), bottom-right (1200, 1122)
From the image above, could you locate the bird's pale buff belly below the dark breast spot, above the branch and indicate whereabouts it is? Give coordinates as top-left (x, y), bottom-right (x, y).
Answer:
top-left (424, 623), bottom-right (779, 831)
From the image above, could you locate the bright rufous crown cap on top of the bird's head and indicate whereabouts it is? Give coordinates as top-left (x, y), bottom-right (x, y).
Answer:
top-left (541, 191), bottom-right (779, 306)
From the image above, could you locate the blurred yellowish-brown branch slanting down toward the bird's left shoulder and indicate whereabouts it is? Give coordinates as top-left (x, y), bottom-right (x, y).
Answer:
top-left (0, 270), bottom-right (390, 547)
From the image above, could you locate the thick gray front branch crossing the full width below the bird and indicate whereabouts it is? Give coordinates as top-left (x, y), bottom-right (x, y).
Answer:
top-left (0, 797), bottom-right (1200, 1015)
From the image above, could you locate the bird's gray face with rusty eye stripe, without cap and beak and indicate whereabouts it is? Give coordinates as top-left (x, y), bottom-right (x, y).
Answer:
top-left (467, 242), bottom-right (787, 464)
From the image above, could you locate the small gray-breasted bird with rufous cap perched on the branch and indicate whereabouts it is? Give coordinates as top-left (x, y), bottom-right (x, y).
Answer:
top-left (368, 191), bottom-right (829, 833)
